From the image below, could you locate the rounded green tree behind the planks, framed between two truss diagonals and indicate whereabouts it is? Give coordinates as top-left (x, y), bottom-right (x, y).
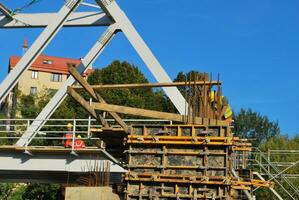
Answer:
top-left (88, 61), bottom-right (169, 110)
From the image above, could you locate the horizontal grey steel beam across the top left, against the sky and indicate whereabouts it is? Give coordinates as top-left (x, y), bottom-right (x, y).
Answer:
top-left (0, 12), bottom-right (112, 28)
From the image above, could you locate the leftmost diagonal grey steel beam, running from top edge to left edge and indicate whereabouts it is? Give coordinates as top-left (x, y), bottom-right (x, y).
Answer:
top-left (0, 0), bottom-right (81, 104)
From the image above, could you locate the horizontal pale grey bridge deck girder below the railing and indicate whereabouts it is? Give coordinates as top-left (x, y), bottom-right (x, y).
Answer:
top-left (0, 151), bottom-right (125, 172)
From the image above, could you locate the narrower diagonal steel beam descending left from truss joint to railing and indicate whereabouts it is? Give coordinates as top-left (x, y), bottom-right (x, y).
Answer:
top-left (16, 24), bottom-right (118, 146)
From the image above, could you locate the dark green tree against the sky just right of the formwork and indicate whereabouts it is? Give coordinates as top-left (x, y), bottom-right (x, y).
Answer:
top-left (234, 109), bottom-right (280, 146)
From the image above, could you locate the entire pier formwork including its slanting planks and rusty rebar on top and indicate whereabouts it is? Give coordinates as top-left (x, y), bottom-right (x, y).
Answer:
top-left (68, 67), bottom-right (274, 200)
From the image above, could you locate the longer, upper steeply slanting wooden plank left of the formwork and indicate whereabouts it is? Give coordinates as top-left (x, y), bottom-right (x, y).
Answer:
top-left (69, 66), bottom-right (129, 132)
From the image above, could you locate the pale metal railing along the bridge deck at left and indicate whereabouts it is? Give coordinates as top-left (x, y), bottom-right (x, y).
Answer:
top-left (0, 118), bottom-right (172, 145)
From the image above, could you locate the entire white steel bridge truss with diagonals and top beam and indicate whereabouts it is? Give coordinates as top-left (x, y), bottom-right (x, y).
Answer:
top-left (0, 0), bottom-right (187, 146)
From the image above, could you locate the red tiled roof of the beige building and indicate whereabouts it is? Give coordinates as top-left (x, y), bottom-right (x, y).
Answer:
top-left (9, 55), bottom-right (88, 76)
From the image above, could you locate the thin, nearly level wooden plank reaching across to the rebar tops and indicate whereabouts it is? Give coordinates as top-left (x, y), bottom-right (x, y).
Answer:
top-left (73, 81), bottom-right (221, 90)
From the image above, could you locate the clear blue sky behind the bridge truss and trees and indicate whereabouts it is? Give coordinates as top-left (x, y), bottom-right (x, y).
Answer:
top-left (0, 0), bottom-right (299, 135)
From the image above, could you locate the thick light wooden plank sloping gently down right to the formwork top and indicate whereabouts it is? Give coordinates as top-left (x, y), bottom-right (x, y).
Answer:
top-left (92, 103), bottom-right (228, 126)
